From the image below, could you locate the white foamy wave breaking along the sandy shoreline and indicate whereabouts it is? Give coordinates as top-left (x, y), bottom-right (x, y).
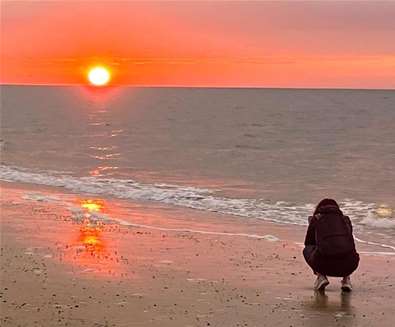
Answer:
top-left (0, 165), bottom-right (395, 229)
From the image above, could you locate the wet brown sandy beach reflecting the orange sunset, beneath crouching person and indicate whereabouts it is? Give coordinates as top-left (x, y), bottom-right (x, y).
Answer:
top-left (0, 183), bottom-right (395, 327)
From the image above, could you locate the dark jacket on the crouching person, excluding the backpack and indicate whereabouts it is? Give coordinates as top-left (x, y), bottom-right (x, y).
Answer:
top-left (303, 206), bottom-right (359, 277)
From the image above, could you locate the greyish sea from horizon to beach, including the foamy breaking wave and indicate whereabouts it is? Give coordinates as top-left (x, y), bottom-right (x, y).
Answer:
top-left (0, 85), bottom-right (395, 251)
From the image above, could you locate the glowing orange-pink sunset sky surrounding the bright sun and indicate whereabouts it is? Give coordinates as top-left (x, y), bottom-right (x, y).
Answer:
top-left (1, 0), bottom-right (395, 88)
